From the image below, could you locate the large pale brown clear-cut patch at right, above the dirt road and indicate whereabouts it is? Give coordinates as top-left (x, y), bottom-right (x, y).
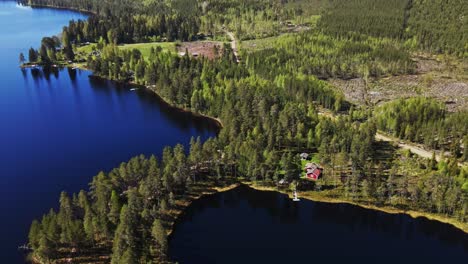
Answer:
top-left (330, 55), bottom-right (468, 111)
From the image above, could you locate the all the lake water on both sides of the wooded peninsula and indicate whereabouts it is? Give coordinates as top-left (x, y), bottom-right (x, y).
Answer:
top-left (0, 1), bottom-right (468, 264)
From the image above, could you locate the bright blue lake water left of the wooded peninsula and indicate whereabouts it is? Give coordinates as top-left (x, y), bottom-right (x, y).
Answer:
top-left (0, 1), bottom-right (217, 264)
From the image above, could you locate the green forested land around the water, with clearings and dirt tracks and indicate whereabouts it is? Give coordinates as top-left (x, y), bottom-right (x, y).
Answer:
top-left (20, 0), bottom-right (468, 264)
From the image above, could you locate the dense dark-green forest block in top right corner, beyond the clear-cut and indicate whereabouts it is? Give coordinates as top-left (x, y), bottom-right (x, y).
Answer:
top-left (319, 0), bottom-right (468, 57)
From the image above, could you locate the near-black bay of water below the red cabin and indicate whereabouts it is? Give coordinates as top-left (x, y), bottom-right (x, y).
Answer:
top-left (170, 186), bottom-right (468, 264)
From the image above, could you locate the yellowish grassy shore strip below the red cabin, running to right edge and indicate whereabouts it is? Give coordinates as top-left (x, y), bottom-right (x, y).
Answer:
top-left (242, 181), bottom-right (468, 234)
